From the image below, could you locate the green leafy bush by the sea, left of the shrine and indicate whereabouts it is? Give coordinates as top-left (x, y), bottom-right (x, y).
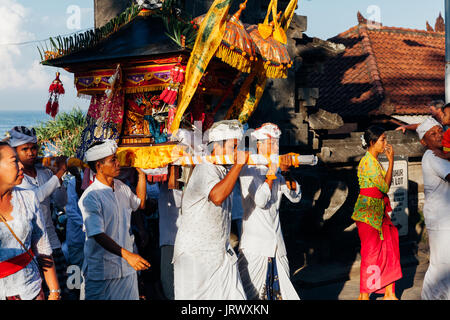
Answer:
top-left (35, 107), bottom-right (87, 157)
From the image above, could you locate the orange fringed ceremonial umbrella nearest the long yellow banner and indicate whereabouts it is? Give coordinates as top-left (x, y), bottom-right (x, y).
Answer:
top-left (193, 0), bottom-right (258, 73)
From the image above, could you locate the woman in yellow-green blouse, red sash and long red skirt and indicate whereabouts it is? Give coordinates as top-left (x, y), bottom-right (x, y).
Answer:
top-left (352, 126), bottom-right (402, 300)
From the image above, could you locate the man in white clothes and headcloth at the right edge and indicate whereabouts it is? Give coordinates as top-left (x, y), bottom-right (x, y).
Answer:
top-left (417, 118), bottom-right (450, 300)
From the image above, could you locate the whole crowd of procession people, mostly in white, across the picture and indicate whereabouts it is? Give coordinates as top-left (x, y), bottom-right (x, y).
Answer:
top-left (0, 104), bottom-right (450, 300)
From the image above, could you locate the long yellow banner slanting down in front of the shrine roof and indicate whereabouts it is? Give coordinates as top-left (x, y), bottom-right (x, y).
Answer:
top-left (171, 0), bottom-right (232, 132)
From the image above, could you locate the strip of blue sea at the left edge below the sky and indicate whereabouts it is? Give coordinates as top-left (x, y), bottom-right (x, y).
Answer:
top-left (0, 109), bottom-right (52, 140)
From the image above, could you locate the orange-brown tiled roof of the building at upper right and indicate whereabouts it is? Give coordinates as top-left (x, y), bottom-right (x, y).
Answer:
top-left (310, 13), bottom-right (445, 117)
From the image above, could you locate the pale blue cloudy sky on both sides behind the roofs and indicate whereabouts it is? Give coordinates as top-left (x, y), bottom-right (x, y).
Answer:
top-left (0, 0), bottom-right (444, 112)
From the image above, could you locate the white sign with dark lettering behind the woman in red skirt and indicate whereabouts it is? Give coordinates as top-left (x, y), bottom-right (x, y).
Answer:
top-left (381, 160), bottom-right (409, 236)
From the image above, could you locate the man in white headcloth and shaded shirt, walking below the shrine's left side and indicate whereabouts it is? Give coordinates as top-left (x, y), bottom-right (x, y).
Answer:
top-left (78, 140), bottom-right (150, 300)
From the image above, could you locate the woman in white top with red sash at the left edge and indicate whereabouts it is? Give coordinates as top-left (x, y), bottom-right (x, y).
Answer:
top-left (0, 142), bottom-right (60, 300)
